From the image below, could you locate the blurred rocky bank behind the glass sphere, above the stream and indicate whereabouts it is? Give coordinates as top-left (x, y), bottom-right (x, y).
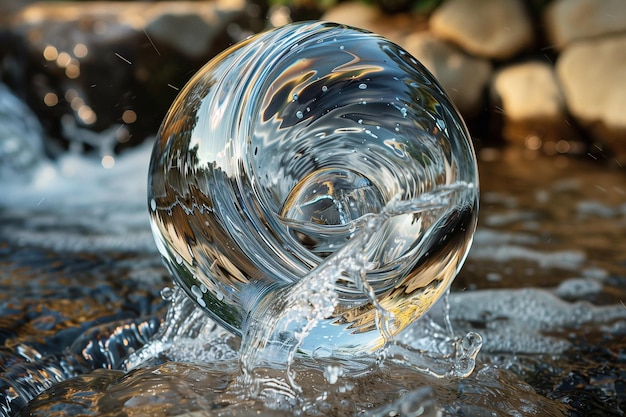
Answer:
top-left (0, 0), bottom-right (626, 164)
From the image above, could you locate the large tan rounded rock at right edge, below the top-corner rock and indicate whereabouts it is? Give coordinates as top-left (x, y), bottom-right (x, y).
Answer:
top-left (556, 35), bottom-right (626, 160)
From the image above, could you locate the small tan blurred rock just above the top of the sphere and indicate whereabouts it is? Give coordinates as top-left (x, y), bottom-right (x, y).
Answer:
top-left (321, 1), bottom-right (427, 44)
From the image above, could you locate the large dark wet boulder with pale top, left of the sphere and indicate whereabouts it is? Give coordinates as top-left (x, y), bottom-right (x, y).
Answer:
top-left (5, 0), bottom-right (254, 154)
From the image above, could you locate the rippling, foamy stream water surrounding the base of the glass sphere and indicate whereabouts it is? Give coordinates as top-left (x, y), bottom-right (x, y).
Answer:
top-left (0, 22), bottom-right (626, 417)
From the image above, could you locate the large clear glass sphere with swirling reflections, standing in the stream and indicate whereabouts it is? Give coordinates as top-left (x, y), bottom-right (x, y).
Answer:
top-left (148, 22), bottom-right (478, 353)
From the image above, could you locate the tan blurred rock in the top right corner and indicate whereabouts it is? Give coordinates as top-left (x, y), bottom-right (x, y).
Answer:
top-left (544, 0), bottom-right (626, 49)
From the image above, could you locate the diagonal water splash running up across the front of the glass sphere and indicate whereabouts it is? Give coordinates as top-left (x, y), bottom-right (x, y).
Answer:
top-left (242, 184), bottom-right (472, 376)
